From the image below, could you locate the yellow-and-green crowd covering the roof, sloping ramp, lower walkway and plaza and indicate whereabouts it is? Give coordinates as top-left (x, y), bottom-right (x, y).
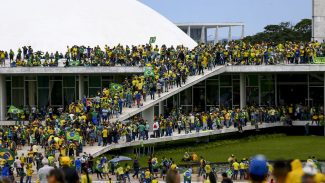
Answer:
top-left (0, 42), bottom-right (324, 183)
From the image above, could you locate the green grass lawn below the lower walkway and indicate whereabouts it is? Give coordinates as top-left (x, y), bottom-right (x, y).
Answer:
top-left (129, 134), bottom-right (325, 166)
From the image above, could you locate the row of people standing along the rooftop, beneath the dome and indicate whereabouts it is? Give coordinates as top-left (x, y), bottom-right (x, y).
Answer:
top-left (0, 41), bottom-right (324, 67)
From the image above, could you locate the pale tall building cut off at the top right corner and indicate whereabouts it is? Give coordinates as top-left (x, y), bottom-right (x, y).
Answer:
top-left (313, 0), bottom-right (325, 42)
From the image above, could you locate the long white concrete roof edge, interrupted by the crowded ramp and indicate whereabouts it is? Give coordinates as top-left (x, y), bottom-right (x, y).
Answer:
top-left (0, 64), bottom-right (325, 75)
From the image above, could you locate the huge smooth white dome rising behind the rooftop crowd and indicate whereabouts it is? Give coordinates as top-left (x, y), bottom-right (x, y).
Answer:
top-left (0, 0), bottom-right (197, 52)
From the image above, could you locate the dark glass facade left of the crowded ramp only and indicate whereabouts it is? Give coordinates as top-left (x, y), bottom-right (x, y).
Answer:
top-left (6, 75), bottom-right (128, 107)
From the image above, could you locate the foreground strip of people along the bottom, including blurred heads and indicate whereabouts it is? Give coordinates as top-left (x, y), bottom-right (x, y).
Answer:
top-left (0, 154), bottom-right (325, 183)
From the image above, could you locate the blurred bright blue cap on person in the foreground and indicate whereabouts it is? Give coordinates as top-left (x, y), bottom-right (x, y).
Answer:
top-left (249, 155), bottom-right (269, 176)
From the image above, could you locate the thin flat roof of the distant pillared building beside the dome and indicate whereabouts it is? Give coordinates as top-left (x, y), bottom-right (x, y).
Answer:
top-left (176, 22), bottom-right (245, 28)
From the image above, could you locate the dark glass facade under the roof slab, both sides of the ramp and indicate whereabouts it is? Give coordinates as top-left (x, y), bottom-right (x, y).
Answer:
top-left (6, 73), bottom-right (324, 113)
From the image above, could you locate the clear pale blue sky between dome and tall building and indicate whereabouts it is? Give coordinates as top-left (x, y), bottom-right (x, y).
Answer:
top-left (140, 0), bottom-right (312, 38)
